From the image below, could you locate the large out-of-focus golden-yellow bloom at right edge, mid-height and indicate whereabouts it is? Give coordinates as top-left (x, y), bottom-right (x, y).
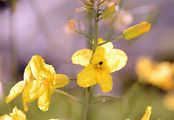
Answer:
top-left (136, 57), bottom-right (174, 91)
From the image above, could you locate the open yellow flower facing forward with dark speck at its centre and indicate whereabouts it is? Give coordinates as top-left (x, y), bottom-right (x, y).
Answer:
top-left (72, 39), bottom-right (127, 92)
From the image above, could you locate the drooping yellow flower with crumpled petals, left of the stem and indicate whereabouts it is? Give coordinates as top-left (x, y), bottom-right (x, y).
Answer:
top-left (6, 55), bottom-right (69, 111)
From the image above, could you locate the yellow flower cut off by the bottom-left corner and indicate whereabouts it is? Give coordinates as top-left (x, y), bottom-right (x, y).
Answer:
top-left (0, 107), bottom-right (26, 120)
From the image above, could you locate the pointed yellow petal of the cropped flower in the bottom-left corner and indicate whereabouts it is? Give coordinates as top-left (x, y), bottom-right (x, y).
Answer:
top-left (10, 107), bottom-right (26, 120)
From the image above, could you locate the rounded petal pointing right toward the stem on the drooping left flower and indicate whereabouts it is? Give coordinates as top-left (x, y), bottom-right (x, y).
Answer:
top-left (53, 74), bottom-right (69, 88)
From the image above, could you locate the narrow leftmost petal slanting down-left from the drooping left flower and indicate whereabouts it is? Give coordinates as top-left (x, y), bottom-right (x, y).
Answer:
top-left (6, 81), bottom-right (25, 103)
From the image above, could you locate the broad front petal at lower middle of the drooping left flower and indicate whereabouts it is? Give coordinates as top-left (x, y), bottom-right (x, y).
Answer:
top-left (22, 80), bottom-right (44, 102)
